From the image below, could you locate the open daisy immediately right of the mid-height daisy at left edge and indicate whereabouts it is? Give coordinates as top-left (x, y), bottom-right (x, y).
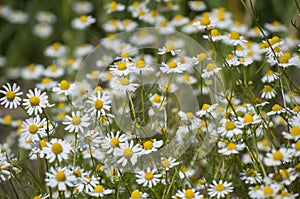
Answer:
top-left (23, 88), bottom-right (51, 115)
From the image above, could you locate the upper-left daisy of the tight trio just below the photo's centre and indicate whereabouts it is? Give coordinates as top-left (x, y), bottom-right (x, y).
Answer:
top-left (101, 131), bottom-right (127, 154)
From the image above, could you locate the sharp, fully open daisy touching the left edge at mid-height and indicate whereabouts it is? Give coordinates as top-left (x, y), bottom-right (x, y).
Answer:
top-left (0, 83), bottom-right (23, 109)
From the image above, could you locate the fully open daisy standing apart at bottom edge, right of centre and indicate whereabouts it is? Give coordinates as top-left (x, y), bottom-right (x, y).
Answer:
top-left (208, 180), bottom-right (233, 198)
